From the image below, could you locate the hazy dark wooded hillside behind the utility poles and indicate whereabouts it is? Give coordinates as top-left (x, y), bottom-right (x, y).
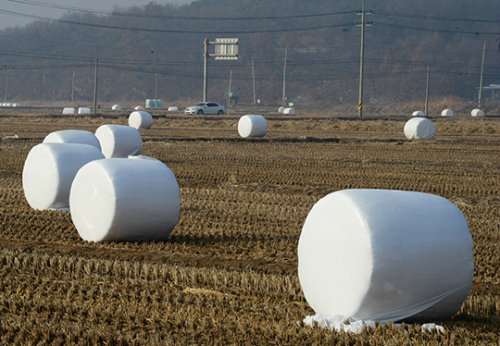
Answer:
top-left (0, 0), bottom-right (500, 105)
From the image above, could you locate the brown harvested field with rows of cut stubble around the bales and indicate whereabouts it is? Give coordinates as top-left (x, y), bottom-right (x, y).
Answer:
top-left (0, 113), bottom-right (500, 345)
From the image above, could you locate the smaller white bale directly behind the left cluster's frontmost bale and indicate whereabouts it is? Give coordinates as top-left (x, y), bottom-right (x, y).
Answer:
top-left (95, 125), bottom-right (142, 159)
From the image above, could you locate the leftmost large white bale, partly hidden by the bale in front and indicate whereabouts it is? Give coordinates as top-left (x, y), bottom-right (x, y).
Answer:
top-left (23, 143), bottom-right (104, 210)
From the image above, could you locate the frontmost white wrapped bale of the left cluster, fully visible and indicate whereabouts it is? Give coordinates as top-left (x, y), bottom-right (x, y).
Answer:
top-left (70, 158), bottom-right (180, 242)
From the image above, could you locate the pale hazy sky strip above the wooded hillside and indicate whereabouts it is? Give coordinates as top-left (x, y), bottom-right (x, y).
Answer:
top-left (0, 0), bottom-right (192, 30)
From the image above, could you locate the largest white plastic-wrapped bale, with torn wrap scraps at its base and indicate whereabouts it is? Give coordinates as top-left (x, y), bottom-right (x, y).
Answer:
top-left (298, 189), bottom-right (474, 322)
